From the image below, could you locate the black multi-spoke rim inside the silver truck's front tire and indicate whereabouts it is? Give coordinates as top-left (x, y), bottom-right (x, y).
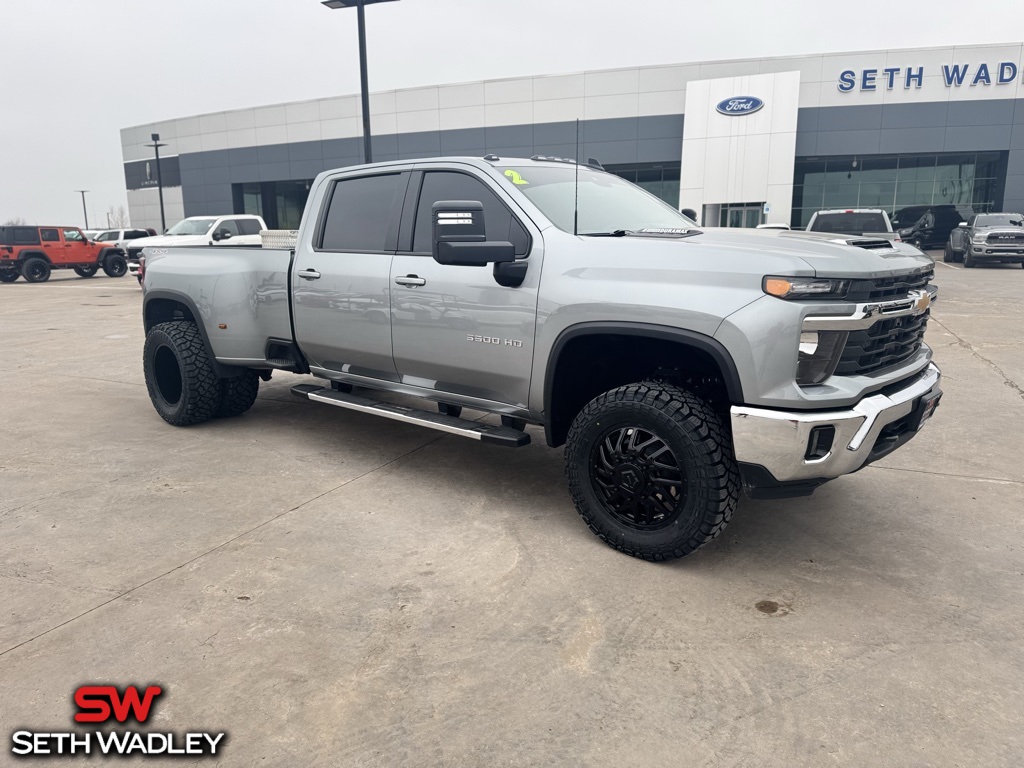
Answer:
top-left (590, 426), bottom-right (687, 530)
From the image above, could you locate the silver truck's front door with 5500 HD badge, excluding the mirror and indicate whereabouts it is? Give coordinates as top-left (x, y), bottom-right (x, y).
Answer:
top-left (391, 167), bottom-right (541, 406)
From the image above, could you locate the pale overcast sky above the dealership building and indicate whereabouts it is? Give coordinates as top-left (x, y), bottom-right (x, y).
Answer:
top-left (0, 0), bottom-right (1024, 224)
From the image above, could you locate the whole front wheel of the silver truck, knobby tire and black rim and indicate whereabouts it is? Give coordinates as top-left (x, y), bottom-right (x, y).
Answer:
top-left (565, 382), bottom-right (739, 560)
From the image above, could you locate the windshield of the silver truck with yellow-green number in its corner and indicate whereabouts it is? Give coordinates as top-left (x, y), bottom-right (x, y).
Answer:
top-left (499, 165), bottom-right (696, 234)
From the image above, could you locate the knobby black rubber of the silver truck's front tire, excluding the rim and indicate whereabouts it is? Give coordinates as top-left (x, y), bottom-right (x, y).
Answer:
top-left (565, 382), bottom-right (740, 560)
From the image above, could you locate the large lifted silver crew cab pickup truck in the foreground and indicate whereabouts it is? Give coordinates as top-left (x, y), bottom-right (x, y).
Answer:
top-left (143, 155), bottom-right (941, 560)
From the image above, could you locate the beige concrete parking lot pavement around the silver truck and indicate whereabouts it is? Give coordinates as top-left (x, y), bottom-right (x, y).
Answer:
top-left (0, 263), bottom-right (1024, 768)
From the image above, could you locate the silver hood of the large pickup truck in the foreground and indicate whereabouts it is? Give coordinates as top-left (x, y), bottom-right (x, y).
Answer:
top-left (664, 228), bottom-right (934, 279)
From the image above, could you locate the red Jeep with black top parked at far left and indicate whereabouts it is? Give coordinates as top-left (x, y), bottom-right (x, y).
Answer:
top-left (0, 226), bottom-right (128, 283)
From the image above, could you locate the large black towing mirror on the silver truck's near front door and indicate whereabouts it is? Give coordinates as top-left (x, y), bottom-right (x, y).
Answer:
top-left (431, 200), bottom-right (515, 266)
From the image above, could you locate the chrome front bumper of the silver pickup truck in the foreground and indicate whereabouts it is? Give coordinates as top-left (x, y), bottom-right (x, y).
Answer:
top-left (730, 362), bottom-right (942, 483)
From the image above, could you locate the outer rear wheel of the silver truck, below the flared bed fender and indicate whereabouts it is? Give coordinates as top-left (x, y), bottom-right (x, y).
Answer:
top-left (142, 321), bottom-right (221, 427)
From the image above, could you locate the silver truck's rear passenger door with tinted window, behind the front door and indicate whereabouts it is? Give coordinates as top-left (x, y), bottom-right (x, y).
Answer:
top-left (291, 171), bottom-right (409, 381)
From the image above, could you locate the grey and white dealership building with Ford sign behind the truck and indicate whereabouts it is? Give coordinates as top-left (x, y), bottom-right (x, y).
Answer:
top-left (121, 44), bottom-right (1024, 228)
